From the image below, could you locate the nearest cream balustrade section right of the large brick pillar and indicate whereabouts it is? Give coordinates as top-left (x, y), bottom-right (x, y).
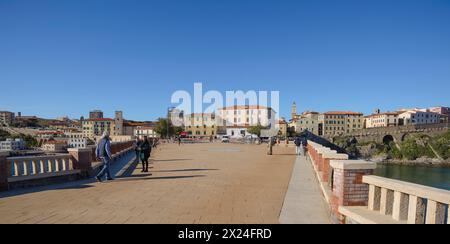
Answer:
top-left (344, 176), bottom-right (450, 224)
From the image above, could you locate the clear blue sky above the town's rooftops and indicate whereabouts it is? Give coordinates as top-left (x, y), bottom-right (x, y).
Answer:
top-left (0, 0), bottom-right (450, 120)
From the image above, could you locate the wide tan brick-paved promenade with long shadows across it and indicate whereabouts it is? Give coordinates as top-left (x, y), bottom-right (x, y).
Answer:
top-left (0, 143), bottom-right (295, 224)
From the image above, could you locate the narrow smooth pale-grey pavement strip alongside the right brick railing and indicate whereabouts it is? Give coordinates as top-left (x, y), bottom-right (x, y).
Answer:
top-left (280, 156), bottom-right (331, 224)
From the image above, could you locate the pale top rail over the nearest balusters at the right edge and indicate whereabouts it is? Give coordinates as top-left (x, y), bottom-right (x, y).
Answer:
top-left (363, 175), bottom-right (450, 204)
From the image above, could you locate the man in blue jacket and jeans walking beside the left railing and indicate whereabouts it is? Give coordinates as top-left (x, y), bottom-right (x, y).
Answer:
top-left (95, 131), bottom-right (114, 182)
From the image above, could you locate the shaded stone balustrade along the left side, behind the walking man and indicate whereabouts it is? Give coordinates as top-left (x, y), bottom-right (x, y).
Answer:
top-left (0, 141), bottom-right (134, 191)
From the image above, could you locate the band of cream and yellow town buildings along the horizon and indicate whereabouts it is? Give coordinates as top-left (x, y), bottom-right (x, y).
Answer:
top-left (0, 102), bottom-right (450, 153)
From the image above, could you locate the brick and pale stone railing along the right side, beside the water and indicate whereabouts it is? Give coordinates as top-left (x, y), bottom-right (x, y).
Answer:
top-left (308, 142), bottom-right (450, 224)
